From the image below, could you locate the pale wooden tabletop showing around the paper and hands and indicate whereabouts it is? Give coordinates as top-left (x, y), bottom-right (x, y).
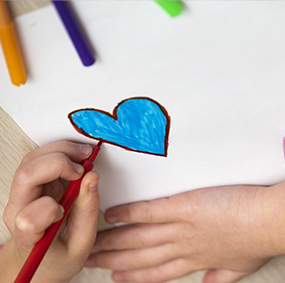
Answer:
top-left (0, 1), bottom-right (285, 283)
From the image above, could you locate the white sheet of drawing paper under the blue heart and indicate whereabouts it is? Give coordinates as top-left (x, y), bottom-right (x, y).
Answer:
top-left (0, 1), bottom-right (285, 210)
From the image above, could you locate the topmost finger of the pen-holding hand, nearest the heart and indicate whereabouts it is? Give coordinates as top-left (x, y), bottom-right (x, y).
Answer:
top-left (22, 141), bottom-right (92, 164)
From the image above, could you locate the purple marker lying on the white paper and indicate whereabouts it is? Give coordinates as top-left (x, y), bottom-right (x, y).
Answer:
top-left (52, 1), bottom-right (95, 66)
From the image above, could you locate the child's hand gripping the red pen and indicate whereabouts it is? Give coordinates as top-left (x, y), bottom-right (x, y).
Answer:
top-left (1, 142), bottom-right (100, 283)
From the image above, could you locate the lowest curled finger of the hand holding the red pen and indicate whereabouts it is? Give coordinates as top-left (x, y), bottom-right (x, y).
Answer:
top-left (13, 196), bottom-right (64, 252)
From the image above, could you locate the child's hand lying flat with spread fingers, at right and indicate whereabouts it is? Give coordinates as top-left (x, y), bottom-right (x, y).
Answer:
top-left (86, 184), bottom-right (285, 283)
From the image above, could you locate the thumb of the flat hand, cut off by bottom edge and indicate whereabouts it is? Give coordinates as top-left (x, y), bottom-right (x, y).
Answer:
top-left (203, 269), bottom-right (247, 283)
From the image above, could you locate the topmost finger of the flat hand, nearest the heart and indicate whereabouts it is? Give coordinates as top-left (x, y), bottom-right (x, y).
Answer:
top-left (105, 197), bottom-right (186, 223)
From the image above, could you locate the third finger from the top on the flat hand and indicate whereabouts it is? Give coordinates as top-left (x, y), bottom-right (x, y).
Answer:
top-left (86, 243), bottom-right (182, 270)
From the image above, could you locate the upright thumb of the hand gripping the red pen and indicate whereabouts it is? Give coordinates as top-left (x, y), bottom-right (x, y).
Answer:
top-left (65, 171), bottom-right (100, 258)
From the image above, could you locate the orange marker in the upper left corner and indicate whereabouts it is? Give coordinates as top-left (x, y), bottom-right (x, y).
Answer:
top-left (0, 0), bottom-right (27, 86)
